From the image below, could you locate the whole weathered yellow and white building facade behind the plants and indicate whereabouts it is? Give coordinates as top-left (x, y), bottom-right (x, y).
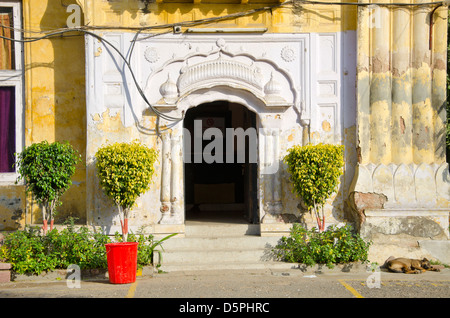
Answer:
top-left (0, 0), bottom-right (450, 264)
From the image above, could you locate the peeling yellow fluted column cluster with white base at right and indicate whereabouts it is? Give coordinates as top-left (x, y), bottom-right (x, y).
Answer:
top-left (349, 0), bottom-right (450, 246)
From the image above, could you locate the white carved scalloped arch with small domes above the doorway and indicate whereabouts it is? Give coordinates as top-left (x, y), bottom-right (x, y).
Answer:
top-left (145, 39), bottom-right (305, 114)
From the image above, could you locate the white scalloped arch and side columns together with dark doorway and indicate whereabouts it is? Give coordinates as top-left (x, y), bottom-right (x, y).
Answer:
top-left (145, 38), bottom-right (308, 234)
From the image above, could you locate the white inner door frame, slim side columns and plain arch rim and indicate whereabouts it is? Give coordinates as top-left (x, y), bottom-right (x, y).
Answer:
top-left (158, 86), bottom-right (288, 232)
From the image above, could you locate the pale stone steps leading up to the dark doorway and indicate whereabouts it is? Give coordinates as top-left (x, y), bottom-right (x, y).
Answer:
top-left (155, 223), bottom-right (292, 271)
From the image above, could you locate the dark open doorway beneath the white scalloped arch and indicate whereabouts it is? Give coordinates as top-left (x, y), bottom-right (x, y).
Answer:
top-left (184, 101), bottom-right (259, 223)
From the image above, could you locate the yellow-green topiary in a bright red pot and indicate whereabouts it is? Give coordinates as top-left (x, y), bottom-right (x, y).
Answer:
top-left (95, 141), bottom-right (157, 284)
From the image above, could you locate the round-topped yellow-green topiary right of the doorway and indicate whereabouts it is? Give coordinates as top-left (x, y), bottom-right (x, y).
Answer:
top-left (284, 144), bottom-right (344, 231)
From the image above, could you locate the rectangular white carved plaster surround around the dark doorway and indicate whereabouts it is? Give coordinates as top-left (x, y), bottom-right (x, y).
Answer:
top-left (87, 32), bottom-right (352, 234)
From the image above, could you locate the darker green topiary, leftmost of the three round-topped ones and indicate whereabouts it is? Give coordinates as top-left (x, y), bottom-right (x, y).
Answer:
top-left (16, 141), bottom-right (81, 233)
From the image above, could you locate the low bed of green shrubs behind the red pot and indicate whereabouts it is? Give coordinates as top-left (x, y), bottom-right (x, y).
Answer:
top-left (0, 219), bottom-right (175, 275)
